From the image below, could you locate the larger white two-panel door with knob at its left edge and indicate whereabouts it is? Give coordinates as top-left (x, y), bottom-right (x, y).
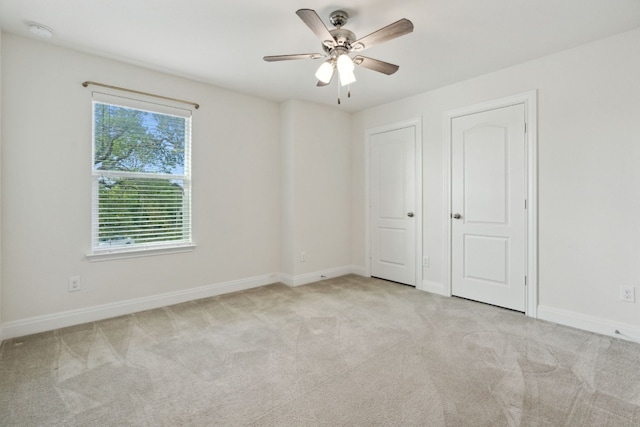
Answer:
top-left (451, 104), bottom-right (527, 311)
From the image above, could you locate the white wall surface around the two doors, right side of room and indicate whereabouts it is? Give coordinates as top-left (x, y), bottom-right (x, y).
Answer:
top-left (352, 29), bottom-right (640, 339)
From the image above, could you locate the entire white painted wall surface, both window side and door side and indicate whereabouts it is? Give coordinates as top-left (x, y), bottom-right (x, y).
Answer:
top-left (0, 26), bottom-right (640, 338)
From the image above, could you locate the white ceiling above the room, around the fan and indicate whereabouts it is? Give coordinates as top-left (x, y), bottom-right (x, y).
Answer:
top-left (0, 0), bottom-right (640, 112)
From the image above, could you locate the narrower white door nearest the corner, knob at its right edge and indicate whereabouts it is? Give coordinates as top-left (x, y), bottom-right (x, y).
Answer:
top-left (370, 127), bottom-right (418, 286)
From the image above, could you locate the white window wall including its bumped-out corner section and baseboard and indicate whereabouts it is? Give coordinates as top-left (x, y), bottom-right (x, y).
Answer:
top-left (0, 34), bottom-right (351, 338)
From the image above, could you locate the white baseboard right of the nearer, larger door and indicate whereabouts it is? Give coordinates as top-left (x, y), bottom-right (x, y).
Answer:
top-left (538, 305), bottom-right (640, 342)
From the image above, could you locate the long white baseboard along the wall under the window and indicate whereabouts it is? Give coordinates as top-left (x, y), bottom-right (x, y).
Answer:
top-left (0, 274), bottom-right (279, 342)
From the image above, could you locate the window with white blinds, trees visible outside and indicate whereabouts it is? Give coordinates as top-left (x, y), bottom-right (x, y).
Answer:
top-left (91, 92), bottom-right (192, 254)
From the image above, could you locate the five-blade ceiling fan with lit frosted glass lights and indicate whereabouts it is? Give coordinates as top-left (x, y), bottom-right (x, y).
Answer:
top-left (263, 9), bottom-right (413, 104)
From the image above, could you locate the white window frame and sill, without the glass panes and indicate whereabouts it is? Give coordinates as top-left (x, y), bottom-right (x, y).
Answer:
top-left (87, 92), bottom-right (195, 261)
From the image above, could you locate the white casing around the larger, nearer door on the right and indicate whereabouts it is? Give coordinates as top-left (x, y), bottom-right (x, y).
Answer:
top-left (442, 90), bottom-right (538, 318)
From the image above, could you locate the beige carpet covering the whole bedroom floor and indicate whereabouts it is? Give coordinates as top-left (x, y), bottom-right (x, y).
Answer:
top-left (0, 276), bottom-right (640, 426)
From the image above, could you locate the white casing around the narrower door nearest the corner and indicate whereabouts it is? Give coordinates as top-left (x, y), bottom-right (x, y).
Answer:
top-left (364, 118), bottom-right (422, 290)
